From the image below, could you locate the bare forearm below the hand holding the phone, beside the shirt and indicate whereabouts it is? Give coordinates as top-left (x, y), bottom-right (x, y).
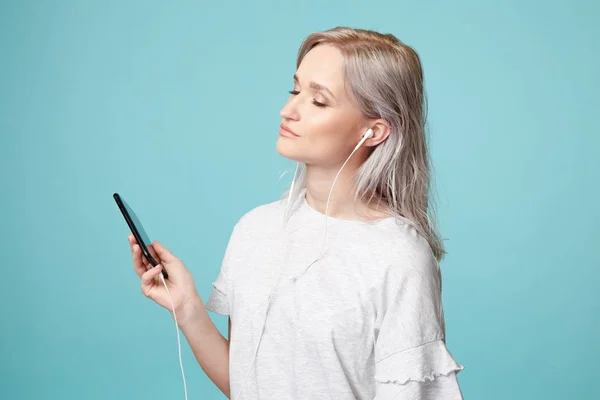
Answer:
top-left (179, 296), bottom-right (231, 398)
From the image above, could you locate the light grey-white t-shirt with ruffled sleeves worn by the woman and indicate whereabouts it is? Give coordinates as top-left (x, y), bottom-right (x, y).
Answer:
top-left (206, 189), bottom-right (463, 400)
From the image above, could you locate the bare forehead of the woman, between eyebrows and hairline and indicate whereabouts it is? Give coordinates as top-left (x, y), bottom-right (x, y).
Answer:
top-left (296, 45), bottom-right (344, 96)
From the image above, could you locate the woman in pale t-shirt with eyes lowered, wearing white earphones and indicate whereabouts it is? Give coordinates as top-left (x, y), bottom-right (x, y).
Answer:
top-left (130, 27), bottom-right (463, 399)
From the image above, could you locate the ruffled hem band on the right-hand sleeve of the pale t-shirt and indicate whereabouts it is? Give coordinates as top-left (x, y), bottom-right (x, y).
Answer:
top-left (375, 339), bottom-right (464, 385)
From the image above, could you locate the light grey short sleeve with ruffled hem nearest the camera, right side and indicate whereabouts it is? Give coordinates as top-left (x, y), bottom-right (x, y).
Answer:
top-left (375, 247), bottom-right (463, 400)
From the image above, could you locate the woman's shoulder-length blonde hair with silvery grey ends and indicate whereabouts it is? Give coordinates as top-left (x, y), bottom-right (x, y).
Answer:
top-left (282, 27), bottom-right (446, 261)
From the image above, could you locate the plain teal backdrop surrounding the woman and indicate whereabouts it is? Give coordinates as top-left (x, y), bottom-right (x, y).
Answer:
top-left (0, 0), bottom-right (600, 400)
